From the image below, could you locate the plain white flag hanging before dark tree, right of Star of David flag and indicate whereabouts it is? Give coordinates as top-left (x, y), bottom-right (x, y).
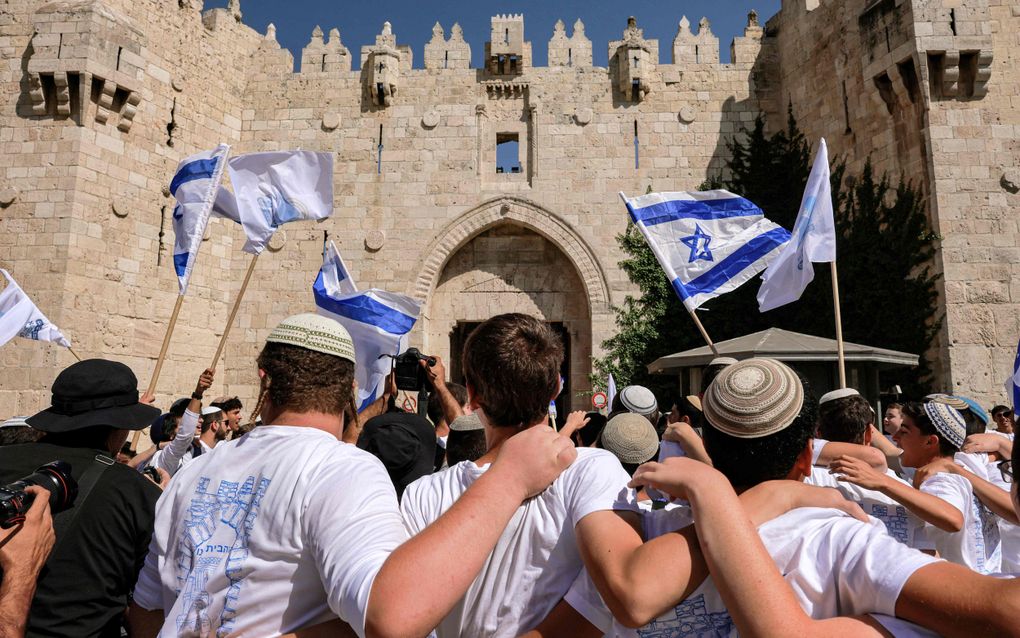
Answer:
top-left (758, 138), bottom-right (835, 312)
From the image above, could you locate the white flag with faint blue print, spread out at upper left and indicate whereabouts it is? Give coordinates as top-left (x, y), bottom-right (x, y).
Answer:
top-left (227, 151), bottom-right (333, 254)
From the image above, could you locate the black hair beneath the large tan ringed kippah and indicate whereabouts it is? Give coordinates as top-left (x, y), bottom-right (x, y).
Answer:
top-left (704, 374), bottom-right (818, 487)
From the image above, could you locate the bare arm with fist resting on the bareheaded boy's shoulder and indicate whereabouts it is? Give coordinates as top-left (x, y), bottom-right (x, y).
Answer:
top-left (365, 427), bottom-right (577, 637)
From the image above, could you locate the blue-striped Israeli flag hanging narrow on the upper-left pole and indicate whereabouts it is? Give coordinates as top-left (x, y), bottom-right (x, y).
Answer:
top-left (170, 144), bottom-right (231, 295)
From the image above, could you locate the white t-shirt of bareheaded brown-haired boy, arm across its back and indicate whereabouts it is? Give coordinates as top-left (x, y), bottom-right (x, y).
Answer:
top-left (400, 447), bottom-right (635, 638)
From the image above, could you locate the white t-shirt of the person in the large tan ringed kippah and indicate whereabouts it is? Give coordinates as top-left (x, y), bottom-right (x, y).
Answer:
top-left (566, 507), bottom-right (937, 638)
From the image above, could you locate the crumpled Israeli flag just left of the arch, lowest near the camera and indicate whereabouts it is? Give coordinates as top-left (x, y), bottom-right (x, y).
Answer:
top-left (312, 256), bottom-right (421, 412)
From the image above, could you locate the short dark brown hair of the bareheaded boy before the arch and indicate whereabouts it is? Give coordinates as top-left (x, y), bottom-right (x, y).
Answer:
top-left (463, 312), bottom-right (563, 428)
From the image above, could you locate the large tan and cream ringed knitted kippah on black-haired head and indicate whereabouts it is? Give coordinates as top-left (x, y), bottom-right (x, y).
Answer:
top-left (702, 358), bottom-right (804, 439)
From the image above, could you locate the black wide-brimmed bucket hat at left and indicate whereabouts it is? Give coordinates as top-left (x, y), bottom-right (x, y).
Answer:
top-left (28, 359), bottom-right (159, 433)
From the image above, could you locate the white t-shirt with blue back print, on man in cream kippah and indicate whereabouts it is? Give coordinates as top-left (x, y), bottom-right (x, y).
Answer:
top-left (135, 426), bottom-right (407, 637)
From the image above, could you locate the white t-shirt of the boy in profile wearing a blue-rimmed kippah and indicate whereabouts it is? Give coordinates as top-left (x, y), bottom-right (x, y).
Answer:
top-left (919, 472), bottom-right (1002, 574)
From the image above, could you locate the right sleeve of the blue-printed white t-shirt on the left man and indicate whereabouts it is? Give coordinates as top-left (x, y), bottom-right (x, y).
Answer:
top-left (302, 454), bottom-right (407, 636)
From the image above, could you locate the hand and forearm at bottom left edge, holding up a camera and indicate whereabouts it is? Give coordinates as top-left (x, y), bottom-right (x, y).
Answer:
top-left (0, 485), bottom-right (56, 638)
